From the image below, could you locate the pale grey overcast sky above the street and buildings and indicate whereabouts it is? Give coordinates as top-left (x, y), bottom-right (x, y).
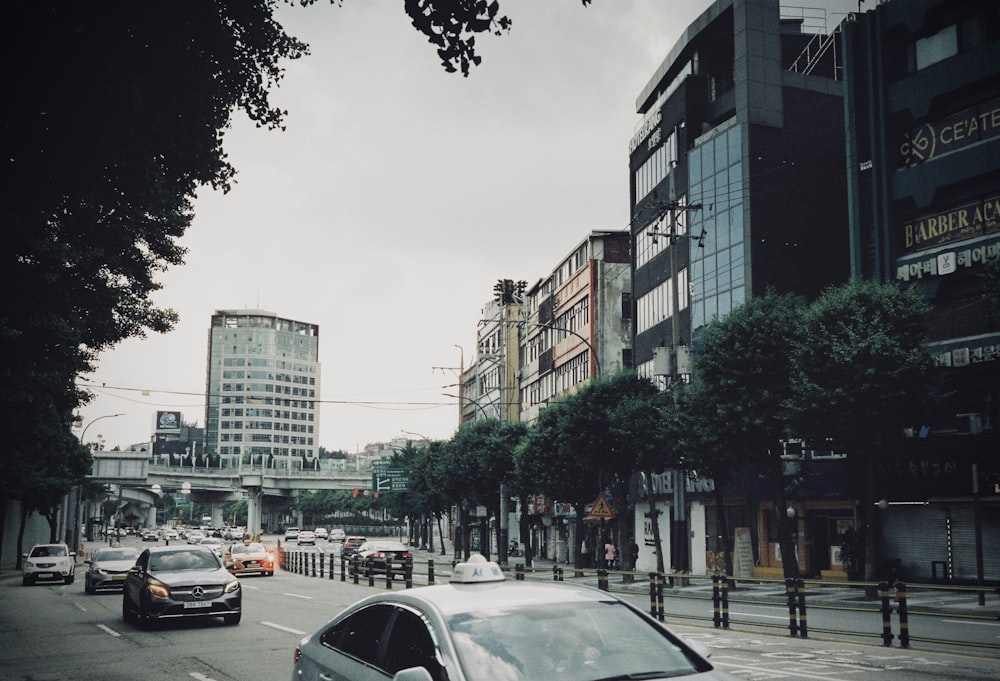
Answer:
top-left (78, 0), bottom-right (870, 452)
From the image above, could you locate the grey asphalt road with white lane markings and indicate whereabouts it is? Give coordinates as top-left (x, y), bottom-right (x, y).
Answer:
top-left (0, 540), bottom-right (1000, 681)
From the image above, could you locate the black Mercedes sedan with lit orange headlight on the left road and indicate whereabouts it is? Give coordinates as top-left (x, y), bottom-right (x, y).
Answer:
top-left (122, 544), bottom-right (243, 629)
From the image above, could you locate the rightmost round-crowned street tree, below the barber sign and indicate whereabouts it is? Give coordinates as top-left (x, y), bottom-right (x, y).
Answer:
top-left (794, 280), bottom-right (933, 581)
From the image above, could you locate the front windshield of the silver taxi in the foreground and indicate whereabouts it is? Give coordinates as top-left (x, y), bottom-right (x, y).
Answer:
top-left (448, 601), bottom-right (711, 681)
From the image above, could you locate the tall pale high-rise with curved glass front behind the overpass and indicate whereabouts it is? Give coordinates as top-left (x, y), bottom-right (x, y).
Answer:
top-left (205, 310), bottom-right (320, 470)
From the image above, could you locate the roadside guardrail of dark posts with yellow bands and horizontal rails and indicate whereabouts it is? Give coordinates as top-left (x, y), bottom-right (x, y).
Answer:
top-left (282, 549), bottom-right (1000, 651)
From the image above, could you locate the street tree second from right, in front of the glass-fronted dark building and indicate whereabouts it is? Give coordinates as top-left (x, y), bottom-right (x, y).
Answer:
top-left (691, 292), bottom-right (805, 578)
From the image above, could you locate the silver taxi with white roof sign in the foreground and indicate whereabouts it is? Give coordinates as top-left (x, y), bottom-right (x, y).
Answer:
top-left (291, 556), bottom-right (736, 681)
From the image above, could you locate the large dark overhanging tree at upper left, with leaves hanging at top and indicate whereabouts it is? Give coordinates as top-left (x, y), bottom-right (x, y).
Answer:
top-left (0, 0), bottom-right (524, 552)
